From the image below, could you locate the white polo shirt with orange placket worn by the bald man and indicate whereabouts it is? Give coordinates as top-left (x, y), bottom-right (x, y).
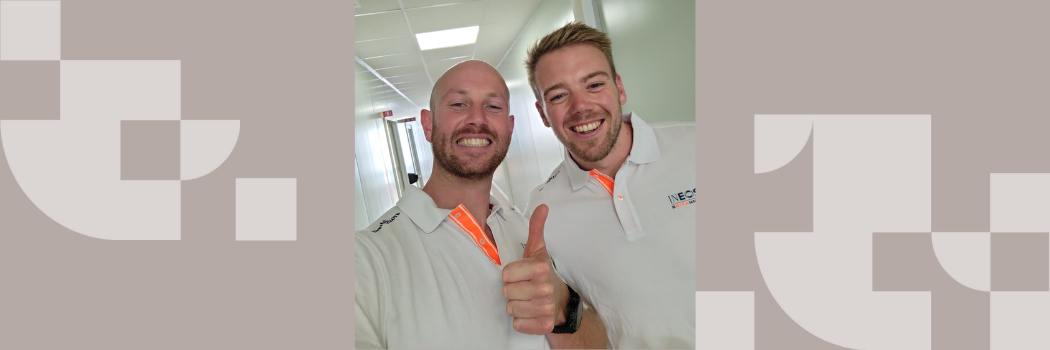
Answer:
top-left (354, 186), bottom-right (549, 349)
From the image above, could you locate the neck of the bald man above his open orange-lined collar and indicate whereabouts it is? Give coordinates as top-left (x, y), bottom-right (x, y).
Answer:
top-left (423, 164), bottom-right (492, 232)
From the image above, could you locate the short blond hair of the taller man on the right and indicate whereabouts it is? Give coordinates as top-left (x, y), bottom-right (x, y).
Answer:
top-left (525, 22), bottom-right (616, 100)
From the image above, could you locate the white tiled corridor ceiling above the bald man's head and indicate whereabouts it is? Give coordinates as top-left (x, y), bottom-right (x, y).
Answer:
top-left (354, 0), bottom-right (543, 108)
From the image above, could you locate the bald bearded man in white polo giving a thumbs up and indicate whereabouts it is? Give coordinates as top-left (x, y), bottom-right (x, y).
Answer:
top-left (354, 61), bottom-right (606, 349)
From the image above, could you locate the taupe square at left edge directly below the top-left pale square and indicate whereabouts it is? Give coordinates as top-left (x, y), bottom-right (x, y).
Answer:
top-left (0, 61), bottom-right (59, 120)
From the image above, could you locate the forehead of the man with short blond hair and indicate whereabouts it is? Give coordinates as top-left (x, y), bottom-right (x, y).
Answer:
top-left (536, 44), bottom-right (612, 80)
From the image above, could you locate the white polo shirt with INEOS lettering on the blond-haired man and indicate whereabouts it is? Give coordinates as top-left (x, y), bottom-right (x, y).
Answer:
top-left (526, 114), bottom-right (696, 349)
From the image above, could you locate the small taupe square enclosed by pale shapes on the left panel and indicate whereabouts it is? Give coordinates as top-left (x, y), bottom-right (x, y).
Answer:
top-left (121, 120), bottom-right (181, 180)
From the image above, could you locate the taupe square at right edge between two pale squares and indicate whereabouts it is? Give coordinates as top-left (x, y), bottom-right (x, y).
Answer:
top-left (991, 232), bottom-right (1050, 291)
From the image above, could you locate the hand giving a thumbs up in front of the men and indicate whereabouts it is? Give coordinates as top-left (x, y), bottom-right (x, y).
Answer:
top-left (503, 204), bottom-right (569, 334)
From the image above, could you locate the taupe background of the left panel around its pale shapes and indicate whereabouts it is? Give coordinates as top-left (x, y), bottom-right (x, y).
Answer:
top-left (0, 0), bottom-right (354, 349)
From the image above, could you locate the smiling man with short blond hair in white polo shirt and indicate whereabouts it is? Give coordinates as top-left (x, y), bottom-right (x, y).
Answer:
top-left (525, 23), bottom-right (696, 349)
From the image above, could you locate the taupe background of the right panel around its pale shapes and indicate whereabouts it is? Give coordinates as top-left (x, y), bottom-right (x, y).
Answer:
top-left (696, 0), bottom-right (1050, 349)
